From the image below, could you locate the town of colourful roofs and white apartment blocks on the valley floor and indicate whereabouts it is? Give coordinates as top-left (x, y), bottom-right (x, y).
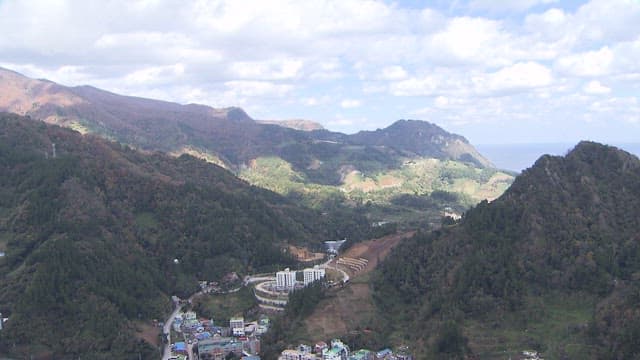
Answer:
top-left (163, 240), bottom-right (413, 360)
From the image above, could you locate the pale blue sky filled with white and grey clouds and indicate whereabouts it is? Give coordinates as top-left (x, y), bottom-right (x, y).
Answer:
top-left (0, 0), bottom-right (640, 144)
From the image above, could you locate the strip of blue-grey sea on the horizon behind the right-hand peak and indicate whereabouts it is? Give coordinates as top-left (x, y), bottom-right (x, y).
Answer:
top-left (474, 143), bottom-right (640, 173)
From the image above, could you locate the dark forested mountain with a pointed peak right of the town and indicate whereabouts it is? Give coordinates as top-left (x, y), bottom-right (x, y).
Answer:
top-left (374, 142), bottom-right (640, 359)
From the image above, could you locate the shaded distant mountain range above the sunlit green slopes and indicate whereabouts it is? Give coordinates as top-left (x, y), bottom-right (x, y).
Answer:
top-left (0, 69), bottom-right (490, 169)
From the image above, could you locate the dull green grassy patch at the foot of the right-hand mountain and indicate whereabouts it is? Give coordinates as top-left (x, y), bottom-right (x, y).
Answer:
top-left (465, 294), bottom-right (595, 359)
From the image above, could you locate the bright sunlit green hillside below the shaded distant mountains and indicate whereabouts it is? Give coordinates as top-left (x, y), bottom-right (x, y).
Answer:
top-left (239, 157), bottom-right (513, 223)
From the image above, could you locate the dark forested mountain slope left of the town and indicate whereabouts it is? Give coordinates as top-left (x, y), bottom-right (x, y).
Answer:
top-left (0, 114), bottom-right (368, 359)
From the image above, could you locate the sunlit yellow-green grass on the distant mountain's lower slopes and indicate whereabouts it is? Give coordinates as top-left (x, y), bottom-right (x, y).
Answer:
top-left (239, 157), bottom-right (513, 221)
